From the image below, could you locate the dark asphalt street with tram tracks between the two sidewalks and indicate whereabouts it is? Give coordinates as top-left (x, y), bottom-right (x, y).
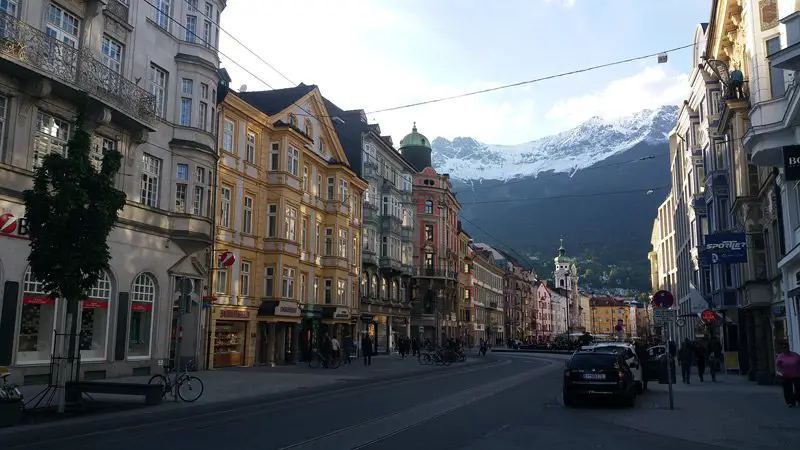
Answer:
top-left (0, 355), bottom-right (721, 450)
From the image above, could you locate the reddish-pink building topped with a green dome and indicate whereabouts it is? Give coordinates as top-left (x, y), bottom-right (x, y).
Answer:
top-left (400, 124), bottom-right (460, 343)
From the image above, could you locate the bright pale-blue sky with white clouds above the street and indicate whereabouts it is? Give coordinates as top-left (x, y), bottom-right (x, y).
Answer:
top-left (220, 0), bottom-right (710, 145)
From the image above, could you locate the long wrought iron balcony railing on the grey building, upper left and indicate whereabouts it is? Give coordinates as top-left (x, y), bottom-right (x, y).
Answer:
top-left (0, 13), bottom-right (156, 125)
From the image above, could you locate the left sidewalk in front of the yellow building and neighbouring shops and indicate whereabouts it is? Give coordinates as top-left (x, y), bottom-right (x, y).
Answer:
top-left (20, 355), bottom-right (482, 409)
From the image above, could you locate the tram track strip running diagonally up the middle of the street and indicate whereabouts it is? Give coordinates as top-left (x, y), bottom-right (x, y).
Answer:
top-left (280, 361), bottom-right (558, 450)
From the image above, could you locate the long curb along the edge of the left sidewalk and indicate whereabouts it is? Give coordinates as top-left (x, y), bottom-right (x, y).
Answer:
top-left (0, 358), bottom-right (501, 448)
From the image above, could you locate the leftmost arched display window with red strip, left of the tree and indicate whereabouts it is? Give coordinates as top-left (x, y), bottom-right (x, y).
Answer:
top-left (17, 268), bottom-right (58, 364)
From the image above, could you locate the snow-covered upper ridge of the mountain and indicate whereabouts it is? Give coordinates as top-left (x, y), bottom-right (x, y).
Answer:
top-left (432, 105), bottom-right (678, 180)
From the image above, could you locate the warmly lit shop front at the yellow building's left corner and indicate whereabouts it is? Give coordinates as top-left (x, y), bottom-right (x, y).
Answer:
top-left (211, 306), bottom-right (255, 368)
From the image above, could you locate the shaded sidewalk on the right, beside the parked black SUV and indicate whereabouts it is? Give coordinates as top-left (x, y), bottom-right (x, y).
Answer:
top-left (580, 374), bottom-right (800, 450)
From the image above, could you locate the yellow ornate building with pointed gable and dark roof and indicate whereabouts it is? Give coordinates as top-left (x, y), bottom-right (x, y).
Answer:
top-left (208, 84), bottom-right (367, 367)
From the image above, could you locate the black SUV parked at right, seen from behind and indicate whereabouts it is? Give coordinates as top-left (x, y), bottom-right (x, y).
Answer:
top-left (563, 351), bottom-right (636, 407)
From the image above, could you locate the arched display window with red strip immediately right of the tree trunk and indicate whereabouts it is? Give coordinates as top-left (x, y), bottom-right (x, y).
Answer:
top-left (79, 272), bottom-right (111, 361)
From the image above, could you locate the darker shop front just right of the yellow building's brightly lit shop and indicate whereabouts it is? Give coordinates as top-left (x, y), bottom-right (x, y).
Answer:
top-left (256, 300), bottom-right (302, 365)
